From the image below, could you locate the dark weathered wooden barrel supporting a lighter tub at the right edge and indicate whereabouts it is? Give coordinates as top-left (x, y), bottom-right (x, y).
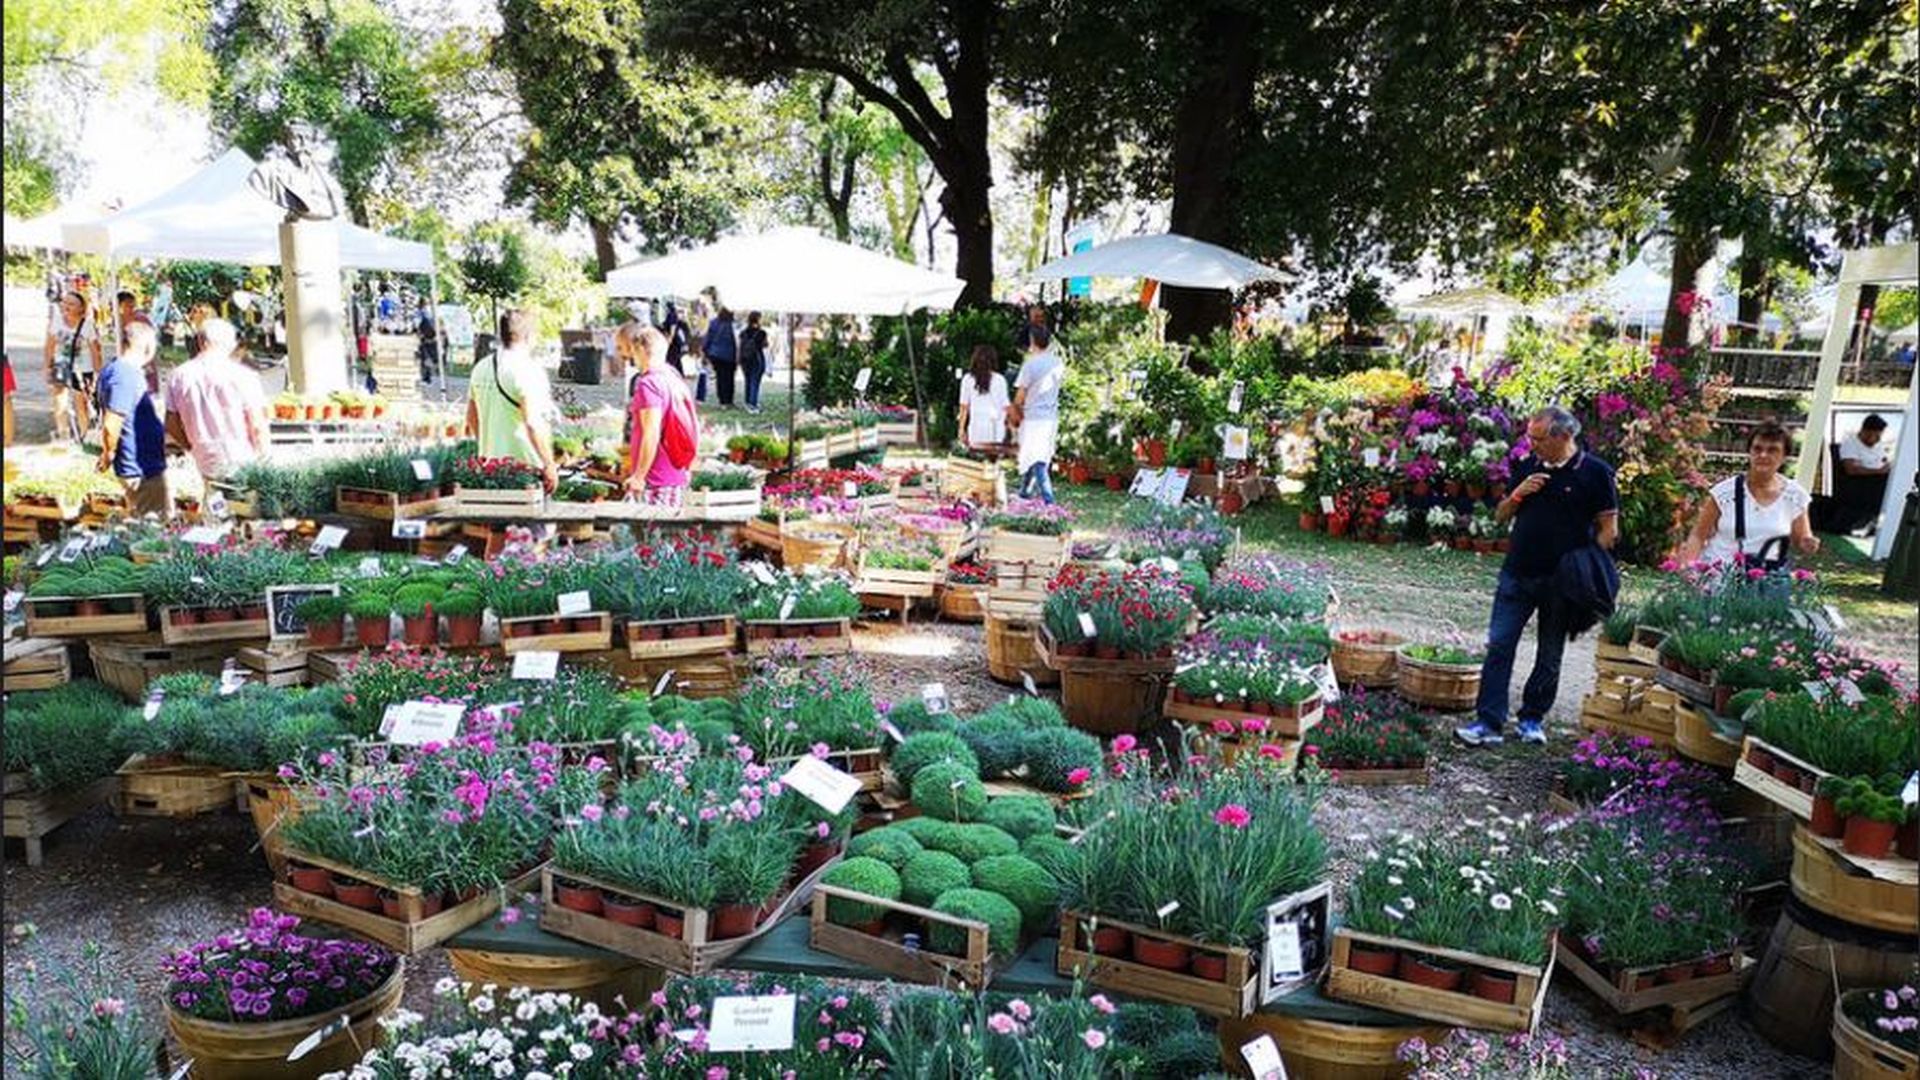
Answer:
top-left (1747, 899), bottom-right (1916, 1057)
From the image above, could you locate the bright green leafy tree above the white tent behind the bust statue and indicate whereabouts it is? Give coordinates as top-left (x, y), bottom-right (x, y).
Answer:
top-left (207, 0), bottom-right (442, 225)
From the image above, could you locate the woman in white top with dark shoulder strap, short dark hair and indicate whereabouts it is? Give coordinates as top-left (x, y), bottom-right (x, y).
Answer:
top-left (1680, 421), bottom-right (1820, 563)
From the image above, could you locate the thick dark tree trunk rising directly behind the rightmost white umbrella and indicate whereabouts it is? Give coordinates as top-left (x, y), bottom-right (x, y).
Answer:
top-left (1160, 10), bottom-right (1258, 340)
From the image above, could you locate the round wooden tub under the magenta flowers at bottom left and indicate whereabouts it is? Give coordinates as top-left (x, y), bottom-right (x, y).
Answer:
top-left (167, 961), bottom-right (407, 1080)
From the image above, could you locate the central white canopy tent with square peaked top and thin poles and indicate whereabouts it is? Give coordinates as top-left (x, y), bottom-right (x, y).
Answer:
top-left (607, 227), bottom-right (966, 461)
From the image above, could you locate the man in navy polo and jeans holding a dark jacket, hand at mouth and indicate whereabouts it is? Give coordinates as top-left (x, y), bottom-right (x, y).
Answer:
top-left (1453, 405), bottom-right (1620, 746)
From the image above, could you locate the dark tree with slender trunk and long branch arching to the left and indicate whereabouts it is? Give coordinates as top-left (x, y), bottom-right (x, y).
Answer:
top-left (647, 0), bottom-right (1004, 306)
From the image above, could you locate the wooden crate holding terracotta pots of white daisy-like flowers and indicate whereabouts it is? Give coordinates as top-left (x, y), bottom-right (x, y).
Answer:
top-left (1327, 926), bottom-right (1553, 1034)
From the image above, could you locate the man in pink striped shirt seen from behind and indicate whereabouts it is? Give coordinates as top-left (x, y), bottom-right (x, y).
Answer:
top-left (167, 319), bottom-right (267, 480)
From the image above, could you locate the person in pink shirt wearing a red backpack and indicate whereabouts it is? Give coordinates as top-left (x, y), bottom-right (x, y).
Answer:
top-left (614, 323), bottom-right (701, 505)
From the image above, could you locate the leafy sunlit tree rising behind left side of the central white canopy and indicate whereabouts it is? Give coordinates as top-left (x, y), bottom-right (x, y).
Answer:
top-left (493, 0), bottom-right (764, 275)
